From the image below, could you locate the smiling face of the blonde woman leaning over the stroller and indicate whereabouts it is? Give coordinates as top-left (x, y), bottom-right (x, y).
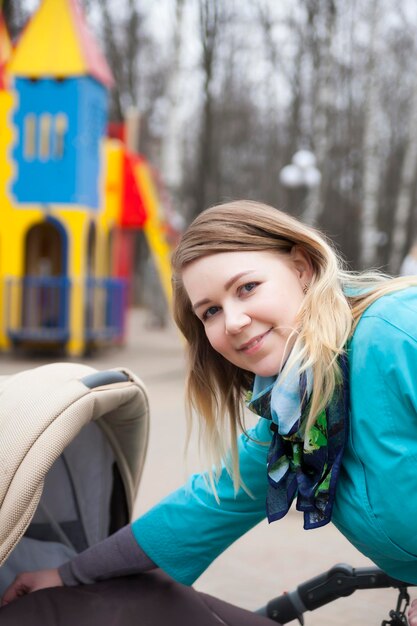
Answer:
top-left (182, 246), bottom-right (313, 376)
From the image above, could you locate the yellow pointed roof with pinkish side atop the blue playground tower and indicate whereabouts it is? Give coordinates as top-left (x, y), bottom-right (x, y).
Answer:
top-left (8, 0), bottom-right (114, 87)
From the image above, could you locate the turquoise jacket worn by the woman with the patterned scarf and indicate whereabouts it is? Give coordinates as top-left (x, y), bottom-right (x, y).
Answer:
top-left (132, 288), bottom-right (417, 584)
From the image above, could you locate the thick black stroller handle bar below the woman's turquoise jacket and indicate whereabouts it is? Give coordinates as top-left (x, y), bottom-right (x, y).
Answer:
top-left (257, 563), bottom-right (409, 624)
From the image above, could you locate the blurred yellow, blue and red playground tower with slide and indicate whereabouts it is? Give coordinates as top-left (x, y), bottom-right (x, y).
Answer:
top-left (0, 0), bottom-right (174, 356)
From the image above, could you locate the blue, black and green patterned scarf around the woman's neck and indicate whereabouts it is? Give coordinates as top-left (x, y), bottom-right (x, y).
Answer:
top-left (247, 356), bottom-right (349, 530)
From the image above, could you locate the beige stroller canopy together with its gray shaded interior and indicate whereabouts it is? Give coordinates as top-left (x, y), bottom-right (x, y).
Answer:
top-left (0, 363), bottom-right (149, 595)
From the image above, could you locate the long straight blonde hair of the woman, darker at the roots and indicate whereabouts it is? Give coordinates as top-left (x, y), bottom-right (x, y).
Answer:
top-left (172, 200), bottom-right (417, 489)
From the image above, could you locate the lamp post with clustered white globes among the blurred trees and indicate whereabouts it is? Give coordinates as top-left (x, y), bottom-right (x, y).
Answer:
top-left (279, 150), bottom-right (321, 224)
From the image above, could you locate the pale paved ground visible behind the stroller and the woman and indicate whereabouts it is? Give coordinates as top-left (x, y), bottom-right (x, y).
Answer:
top-left (0, 310), bottom-right (410, 626)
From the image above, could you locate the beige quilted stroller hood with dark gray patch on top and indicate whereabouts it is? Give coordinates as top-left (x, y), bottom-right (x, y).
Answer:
top-left (0, 363), bottom-right (149, 564)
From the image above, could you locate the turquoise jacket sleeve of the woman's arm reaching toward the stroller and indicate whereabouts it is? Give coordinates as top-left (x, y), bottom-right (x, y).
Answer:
top-left (132, 418), bottom-right (271, 585)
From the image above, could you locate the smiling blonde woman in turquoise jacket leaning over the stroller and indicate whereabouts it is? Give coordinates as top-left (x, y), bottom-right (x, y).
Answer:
top-left (4, 201), bottom-right (417, 625)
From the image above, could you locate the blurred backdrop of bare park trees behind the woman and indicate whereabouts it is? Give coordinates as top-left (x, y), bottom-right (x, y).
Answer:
top-left (4, 0), bottom-right (417, 272)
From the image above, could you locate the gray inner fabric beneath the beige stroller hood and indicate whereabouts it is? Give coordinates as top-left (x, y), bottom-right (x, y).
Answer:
top-left (0, 422), bottom-right (114, 595)
